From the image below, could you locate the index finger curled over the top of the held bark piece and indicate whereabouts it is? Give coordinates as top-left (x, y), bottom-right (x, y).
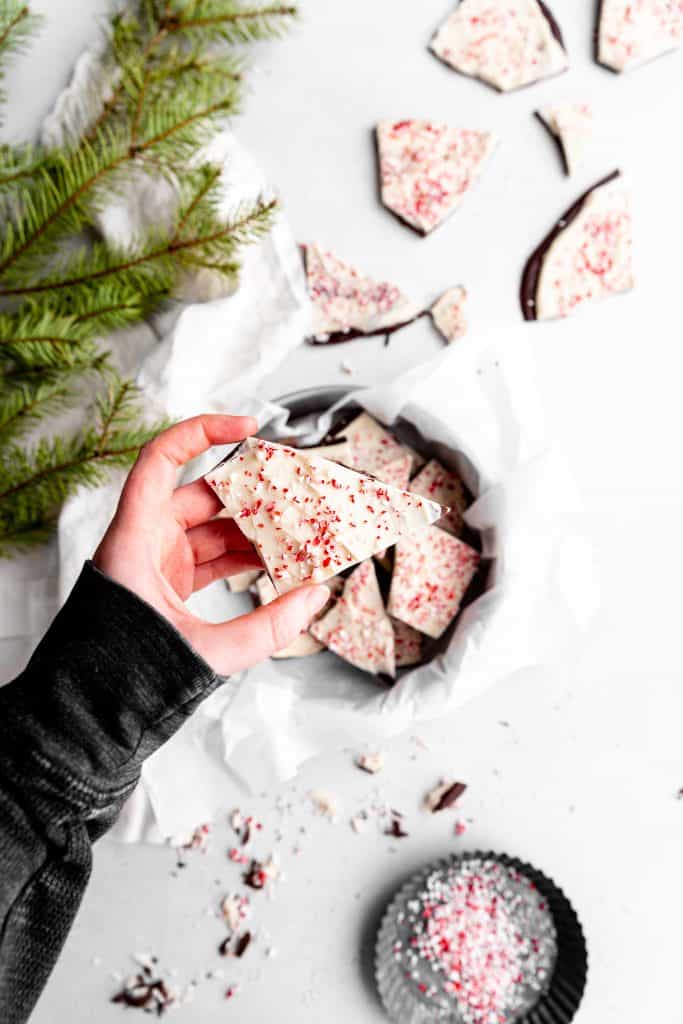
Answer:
top-left (118, 415), bottom-right (257, 513)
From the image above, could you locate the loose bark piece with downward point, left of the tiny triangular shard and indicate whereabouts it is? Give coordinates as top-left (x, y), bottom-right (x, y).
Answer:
top-left (377, 120), bottom-right (496, 234)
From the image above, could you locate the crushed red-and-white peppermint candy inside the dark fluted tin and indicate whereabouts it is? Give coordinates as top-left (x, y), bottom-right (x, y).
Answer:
top-left (393, 857), bottom-right (557, 1024)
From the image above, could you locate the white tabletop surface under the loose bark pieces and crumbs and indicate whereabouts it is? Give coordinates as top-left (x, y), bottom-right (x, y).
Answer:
top-left (5, 0), bottom-right (683, 1024)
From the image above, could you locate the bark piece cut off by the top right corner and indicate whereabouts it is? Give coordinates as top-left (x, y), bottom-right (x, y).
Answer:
top-left (597, 0), bottom-right (683, 72)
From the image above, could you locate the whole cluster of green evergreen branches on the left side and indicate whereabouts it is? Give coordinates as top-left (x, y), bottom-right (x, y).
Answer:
top-left (0, 0), bottom-right (296, 556)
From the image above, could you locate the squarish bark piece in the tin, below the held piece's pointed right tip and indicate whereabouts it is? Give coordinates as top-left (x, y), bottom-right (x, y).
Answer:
top-left (387, 526), bottom-right (479, 639)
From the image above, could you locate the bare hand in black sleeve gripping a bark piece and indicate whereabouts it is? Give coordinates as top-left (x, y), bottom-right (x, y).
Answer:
top-left (94, 416), bottom-right (329, 675)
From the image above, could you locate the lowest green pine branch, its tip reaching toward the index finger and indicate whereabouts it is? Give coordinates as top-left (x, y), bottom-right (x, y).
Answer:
top-left (0, 378), bottom-right (167, 557)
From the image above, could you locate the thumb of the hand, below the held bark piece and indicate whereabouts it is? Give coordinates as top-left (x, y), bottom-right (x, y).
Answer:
top-left (191, 586), bottom-right (330, 676)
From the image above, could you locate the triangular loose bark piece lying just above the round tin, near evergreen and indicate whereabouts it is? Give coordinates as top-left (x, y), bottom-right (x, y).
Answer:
top-left (303, 245), bottom-right (424, 345)
